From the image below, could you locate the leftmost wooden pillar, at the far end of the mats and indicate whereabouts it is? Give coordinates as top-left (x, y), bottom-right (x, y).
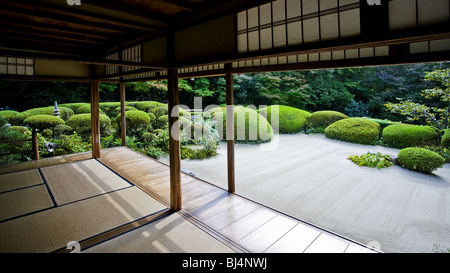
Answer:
top-left (91, 80), bottom-right (100, 158)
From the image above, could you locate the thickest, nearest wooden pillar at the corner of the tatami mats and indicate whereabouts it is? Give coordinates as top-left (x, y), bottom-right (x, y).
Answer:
top-left (167, 68), bottom-right (181, 211)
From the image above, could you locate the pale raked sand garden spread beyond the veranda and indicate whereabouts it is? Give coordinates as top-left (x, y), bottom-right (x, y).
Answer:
top-left (160, 134), bottom-right (450, 253)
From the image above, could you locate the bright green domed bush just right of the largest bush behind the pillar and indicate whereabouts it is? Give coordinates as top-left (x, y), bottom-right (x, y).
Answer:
top-left (258, 105), bottom-right (311, 134)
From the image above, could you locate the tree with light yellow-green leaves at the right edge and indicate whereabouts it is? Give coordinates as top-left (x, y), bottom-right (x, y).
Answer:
top-left (386, 68), bottom-right (450, 130)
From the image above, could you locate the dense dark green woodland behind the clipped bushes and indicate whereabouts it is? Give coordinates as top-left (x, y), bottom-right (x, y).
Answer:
top-left (0, 62), bottom-right (450, 120)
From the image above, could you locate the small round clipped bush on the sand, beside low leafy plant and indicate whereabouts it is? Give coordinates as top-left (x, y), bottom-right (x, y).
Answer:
top-left (398, 148), bottom-right (445, 173)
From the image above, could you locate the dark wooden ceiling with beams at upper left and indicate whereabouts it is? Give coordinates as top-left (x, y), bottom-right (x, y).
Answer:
top-left (0, 0), bottom-right (268, 59)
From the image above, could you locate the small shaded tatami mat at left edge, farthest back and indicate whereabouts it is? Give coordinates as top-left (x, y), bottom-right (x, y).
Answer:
top-left (0, 169), bottom-right (44, 193)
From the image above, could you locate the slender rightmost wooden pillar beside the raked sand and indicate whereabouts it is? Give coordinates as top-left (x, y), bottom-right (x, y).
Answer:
top-left (225, 64), bottom-right (235, 193)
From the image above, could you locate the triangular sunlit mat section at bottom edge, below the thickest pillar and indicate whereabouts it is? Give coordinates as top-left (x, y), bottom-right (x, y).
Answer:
top-left (85, 213), bottom-right (237, 253)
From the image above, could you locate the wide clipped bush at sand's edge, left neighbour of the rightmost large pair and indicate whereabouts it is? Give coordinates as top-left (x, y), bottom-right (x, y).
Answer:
top-left (325, 118), bottom-right (380, 144)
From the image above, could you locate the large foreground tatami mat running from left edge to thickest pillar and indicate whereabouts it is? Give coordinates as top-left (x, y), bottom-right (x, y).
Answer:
top-left (0, 187), bottom-right (166, 253)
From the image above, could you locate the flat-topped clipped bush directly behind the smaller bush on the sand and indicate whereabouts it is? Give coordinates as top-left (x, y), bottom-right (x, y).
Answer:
top-left (383, 124), bottom-right (439, 149)
